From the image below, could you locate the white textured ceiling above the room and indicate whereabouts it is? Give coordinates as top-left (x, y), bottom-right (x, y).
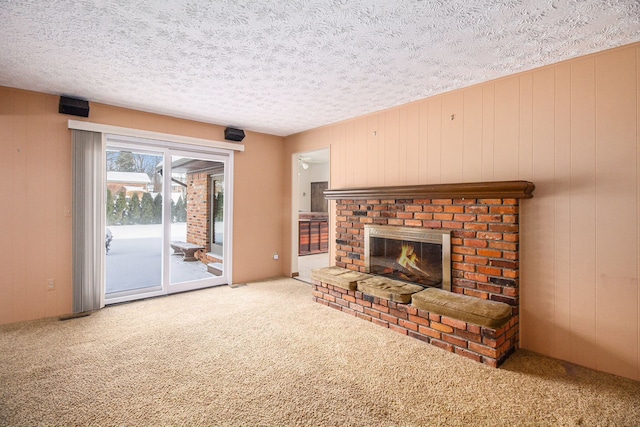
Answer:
top-left (0, 0), bottom-right (640, 135)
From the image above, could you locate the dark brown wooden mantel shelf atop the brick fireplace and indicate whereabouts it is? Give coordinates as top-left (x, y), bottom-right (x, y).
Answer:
top-left (324, 181), bottom-right (535, 200)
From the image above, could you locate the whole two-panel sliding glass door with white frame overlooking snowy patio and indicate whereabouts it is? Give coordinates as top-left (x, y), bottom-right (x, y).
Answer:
top-left (105, 136), bottom-right (232, 304)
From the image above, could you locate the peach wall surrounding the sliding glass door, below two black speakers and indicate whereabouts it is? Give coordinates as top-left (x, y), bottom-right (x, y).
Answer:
top-left (0, 87), bottom-right (283, 324)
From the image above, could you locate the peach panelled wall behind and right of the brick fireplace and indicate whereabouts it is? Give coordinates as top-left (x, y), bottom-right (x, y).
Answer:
top-left (284, 44), bottom-right (640, 380)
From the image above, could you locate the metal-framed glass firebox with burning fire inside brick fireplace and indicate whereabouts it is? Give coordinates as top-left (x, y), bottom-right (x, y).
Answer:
top-left (364, 225), bottom-right (451, 291)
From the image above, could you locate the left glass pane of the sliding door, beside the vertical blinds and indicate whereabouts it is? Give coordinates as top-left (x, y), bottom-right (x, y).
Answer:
top-left (105, 147), bottom-right (164, 301)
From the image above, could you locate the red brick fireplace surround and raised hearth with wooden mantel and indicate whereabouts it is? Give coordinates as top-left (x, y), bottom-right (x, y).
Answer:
top-left (314, 181), bottom-right (534, 366)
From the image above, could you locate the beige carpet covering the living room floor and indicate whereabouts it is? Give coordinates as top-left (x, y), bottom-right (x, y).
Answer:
top-left (0, 279), bottom-right (640, 426)
